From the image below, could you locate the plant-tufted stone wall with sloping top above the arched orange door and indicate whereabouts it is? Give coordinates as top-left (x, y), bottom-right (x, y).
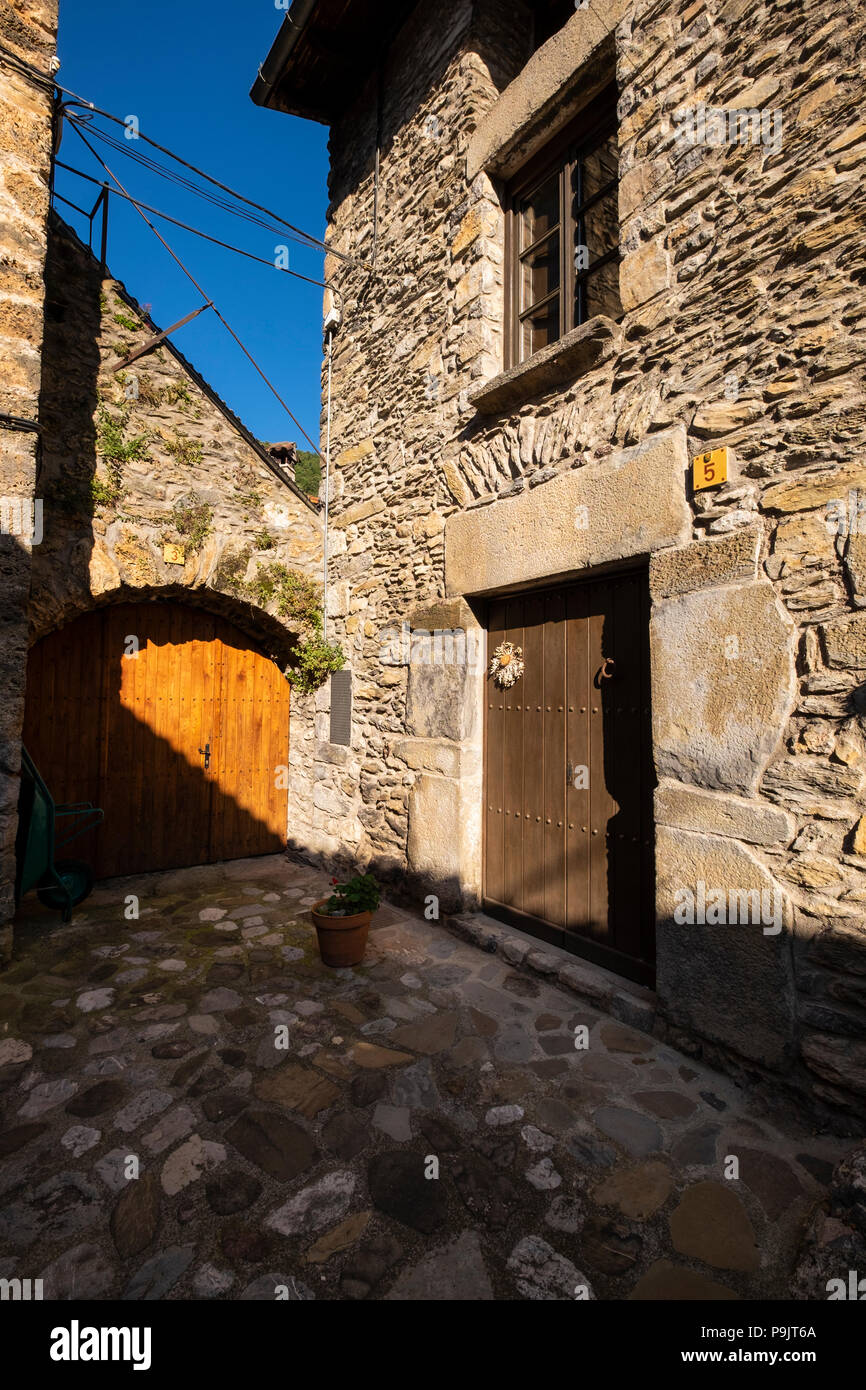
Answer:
top-left (29, 217), bottom-right (322, 906)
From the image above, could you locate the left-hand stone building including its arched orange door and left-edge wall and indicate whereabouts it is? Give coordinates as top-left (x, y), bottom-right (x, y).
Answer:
top-left (0, 3), bottom-right (322, 956)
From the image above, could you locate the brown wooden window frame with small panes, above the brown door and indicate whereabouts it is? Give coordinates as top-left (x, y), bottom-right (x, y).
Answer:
top-left (503, 82), bottom-right (620, 371)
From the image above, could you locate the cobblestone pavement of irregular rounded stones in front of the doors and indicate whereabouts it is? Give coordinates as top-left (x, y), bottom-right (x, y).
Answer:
top-left (0, 856), bottom-right (852, 1300)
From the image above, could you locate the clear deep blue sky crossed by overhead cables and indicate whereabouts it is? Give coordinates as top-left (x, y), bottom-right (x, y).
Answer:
top-left (57, 0), bottom-right (328, 448)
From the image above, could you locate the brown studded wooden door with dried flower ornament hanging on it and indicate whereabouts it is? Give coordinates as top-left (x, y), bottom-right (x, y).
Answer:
top-left (484, 570), bottom-right (655, 983)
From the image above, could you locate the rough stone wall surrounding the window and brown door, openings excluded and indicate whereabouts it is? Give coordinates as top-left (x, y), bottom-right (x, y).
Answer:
top-left (289, 0), bottom-right (866, 1111)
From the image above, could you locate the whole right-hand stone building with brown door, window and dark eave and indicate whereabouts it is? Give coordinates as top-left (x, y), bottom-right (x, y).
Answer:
top-left (252, 0), bottom-right (866, 1112)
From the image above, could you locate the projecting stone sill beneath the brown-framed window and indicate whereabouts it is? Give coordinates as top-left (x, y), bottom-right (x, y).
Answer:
top-left (468, 314), bottom-right (620, 416)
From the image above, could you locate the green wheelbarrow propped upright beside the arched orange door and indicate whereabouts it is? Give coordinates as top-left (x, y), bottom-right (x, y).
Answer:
top-left (15, 748), bottom-right (104, 922)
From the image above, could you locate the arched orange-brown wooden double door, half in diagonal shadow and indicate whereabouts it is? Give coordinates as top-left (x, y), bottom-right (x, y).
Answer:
top-left (24, 602), bottom-right (291, 878)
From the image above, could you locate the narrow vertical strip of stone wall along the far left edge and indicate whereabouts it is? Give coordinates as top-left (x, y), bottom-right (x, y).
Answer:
top-left (0, 0), bottom-right (57, 960)
